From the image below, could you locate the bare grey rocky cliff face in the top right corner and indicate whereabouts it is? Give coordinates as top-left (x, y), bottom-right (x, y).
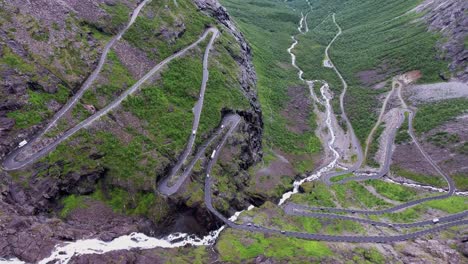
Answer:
top-left (417, 0), bottom-right (468, 82)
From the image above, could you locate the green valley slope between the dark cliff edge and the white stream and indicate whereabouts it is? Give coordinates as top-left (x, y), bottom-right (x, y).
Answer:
top-left (221, 0), bottom-right (320, 167)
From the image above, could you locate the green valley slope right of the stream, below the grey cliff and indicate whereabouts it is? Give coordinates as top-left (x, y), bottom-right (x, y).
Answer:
top-left (298, 0), bottom-right (447, 142)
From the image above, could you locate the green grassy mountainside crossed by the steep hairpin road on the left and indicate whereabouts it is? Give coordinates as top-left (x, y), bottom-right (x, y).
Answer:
top-left (9, 0), bottom-right (250, 225)
